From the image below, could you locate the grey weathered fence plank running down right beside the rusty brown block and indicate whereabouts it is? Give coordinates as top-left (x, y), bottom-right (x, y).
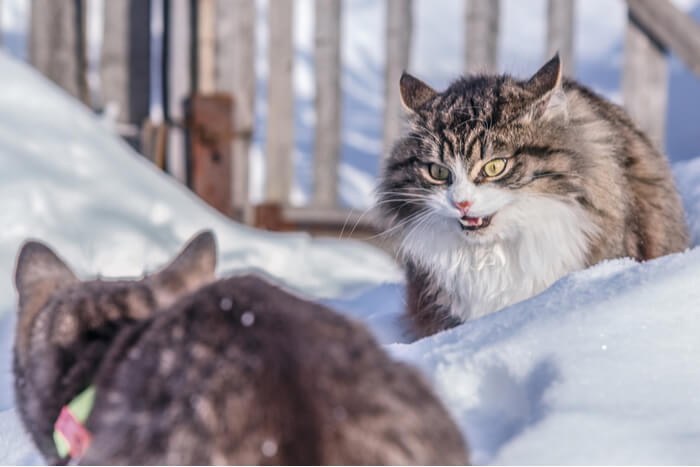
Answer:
top-left (216, 0), bottom-right (256, 223)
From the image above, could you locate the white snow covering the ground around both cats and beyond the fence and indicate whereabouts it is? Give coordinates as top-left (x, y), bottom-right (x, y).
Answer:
top-left (0, 5), bottom-right (700, 464)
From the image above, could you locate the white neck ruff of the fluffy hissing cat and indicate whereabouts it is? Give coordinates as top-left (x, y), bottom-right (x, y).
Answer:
top-left (401, 196), bottom-right (596, 321)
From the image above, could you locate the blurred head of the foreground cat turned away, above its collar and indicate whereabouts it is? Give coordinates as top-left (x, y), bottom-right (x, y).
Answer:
top-left (13, 232), bottom-right (216, 463)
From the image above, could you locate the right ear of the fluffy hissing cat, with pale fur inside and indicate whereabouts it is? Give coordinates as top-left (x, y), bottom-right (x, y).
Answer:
top-left (524, 52), bottom-right (568, 120)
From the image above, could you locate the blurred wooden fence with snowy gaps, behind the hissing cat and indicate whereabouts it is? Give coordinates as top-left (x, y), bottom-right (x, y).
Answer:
top-left (0, 0), bottom-right (700, 236)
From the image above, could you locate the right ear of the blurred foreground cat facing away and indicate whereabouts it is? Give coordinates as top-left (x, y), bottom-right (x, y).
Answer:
top-left (148, 230), bottom-right (216, 307)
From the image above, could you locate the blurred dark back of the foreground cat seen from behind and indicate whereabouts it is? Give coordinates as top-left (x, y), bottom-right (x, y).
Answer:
top-left (84, 276), bottom-right (467, 464)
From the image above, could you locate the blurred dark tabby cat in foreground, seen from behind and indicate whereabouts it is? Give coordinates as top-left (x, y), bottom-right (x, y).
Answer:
top-left (14, 233), bottom-right (467, 465)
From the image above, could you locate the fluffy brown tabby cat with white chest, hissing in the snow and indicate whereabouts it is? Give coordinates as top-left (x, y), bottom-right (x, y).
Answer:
top-left (377, 55), bottom-right (688, 336)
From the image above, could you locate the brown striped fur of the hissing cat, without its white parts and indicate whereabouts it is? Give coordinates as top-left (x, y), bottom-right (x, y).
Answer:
top-left (377, 56), bottom-right (688, 336)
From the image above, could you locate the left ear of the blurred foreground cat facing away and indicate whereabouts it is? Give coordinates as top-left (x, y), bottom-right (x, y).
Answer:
top-left (15, 240), bottom-right (79, 313)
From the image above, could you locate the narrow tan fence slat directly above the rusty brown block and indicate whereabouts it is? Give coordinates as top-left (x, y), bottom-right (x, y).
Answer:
top-left (197, 0), bottom-right (216, 93)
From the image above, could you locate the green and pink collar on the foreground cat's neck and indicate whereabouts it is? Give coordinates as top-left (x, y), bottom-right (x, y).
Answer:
top-left (53, 385), bottom-right (95, 460)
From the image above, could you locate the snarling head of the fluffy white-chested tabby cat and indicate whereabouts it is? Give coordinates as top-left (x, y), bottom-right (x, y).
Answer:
top-left (377, 55), bottom-right (586, 258)
